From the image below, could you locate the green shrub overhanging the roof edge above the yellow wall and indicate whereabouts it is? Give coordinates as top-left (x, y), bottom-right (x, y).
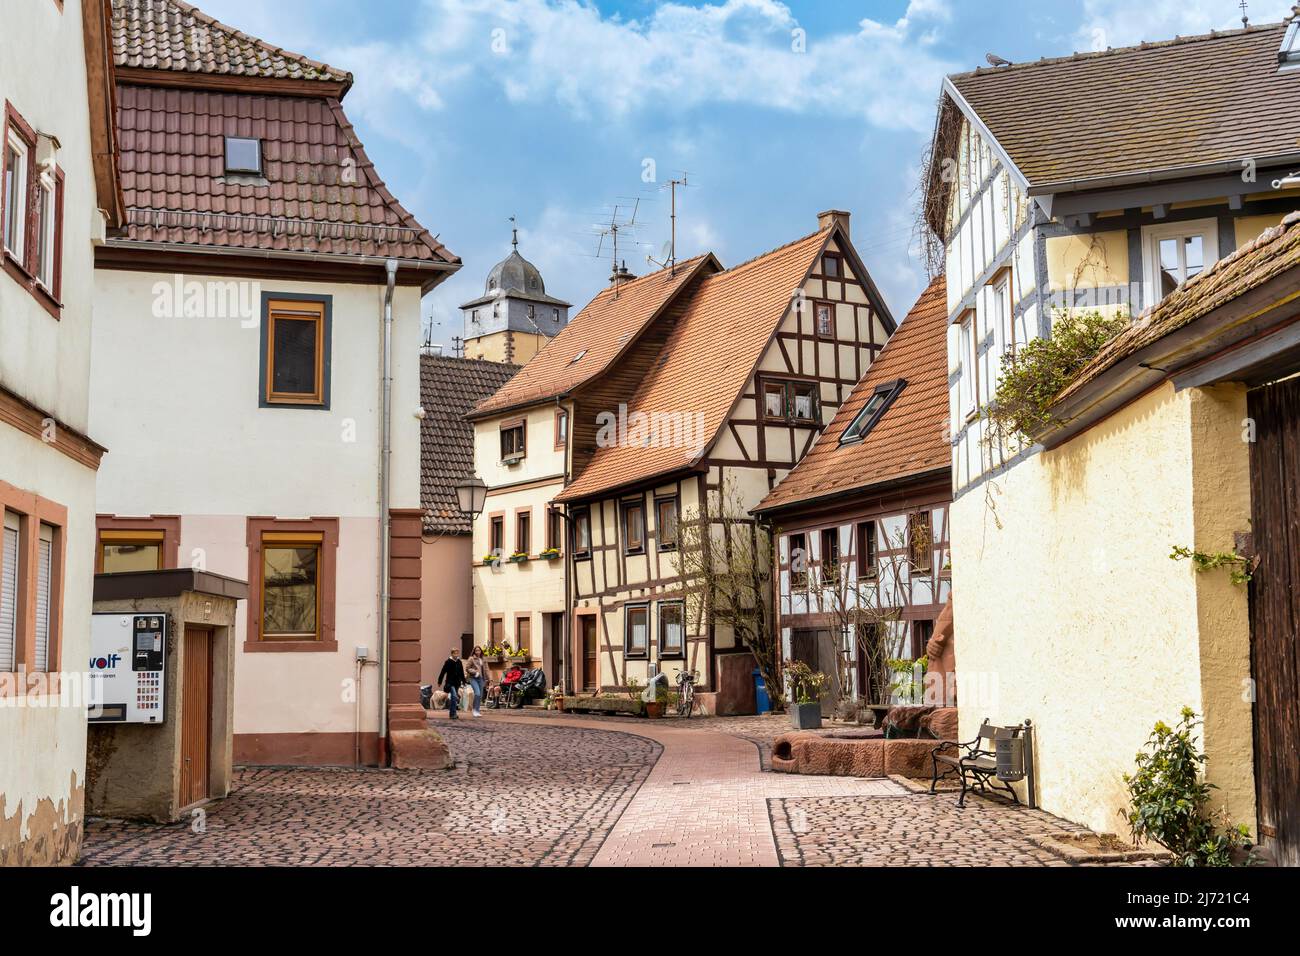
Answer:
top-left (983, 310), bottom-right (1128, 442)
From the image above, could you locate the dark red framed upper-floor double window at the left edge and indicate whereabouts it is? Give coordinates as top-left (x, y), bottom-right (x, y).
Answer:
top-left (0, 100), bottom-right (64, 319)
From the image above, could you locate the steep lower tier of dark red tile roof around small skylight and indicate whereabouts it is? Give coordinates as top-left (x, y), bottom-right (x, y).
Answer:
top-left (117, 85), bottom-right (460, 263)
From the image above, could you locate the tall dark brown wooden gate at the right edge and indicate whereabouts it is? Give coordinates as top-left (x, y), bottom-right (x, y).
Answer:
top-left (1247, 380), bottom-right (1300, 866)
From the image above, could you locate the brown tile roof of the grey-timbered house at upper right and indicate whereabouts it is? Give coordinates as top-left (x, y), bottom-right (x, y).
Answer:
top-left (950, 23), bottom-right (1300, 186)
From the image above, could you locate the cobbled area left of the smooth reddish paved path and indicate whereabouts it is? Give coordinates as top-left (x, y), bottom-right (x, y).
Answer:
top-left (82, 719), bottom-right (660, 866)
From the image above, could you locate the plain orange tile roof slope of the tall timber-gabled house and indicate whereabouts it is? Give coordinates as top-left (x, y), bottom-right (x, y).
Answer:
top-left (556, 228), bottom-right (832, 501)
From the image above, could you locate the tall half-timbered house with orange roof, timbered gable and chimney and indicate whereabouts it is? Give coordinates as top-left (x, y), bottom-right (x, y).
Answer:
top-left (558, 211), bottom-right (894, 710)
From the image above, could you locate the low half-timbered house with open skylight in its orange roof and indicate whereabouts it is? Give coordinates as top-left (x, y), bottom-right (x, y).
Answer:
top-left (754, 277), bottom-right (952, 706)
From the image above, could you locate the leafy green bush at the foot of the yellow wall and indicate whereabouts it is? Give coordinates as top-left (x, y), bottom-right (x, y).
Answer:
top-left (1123, 708), bottom-right (1251, 866)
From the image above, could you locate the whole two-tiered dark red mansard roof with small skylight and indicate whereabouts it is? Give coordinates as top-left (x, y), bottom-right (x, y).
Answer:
top-left (113, 0), bottom-right (460, 268)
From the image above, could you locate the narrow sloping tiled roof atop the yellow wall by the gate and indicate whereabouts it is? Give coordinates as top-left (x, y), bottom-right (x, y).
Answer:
top-left (1054, 211), bottom-right (1300, 403)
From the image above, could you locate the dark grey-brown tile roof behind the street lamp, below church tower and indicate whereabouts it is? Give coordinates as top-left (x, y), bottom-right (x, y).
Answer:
top-left (420, 355), bottom-right (519, 535)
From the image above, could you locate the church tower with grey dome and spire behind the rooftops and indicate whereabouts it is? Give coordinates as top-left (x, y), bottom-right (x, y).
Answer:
top-left (460, 229), bottom-right (571, 365)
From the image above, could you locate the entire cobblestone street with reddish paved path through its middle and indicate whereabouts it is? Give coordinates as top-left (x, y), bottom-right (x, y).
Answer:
top-left (82, 711), bottom-right (1138, 866)
